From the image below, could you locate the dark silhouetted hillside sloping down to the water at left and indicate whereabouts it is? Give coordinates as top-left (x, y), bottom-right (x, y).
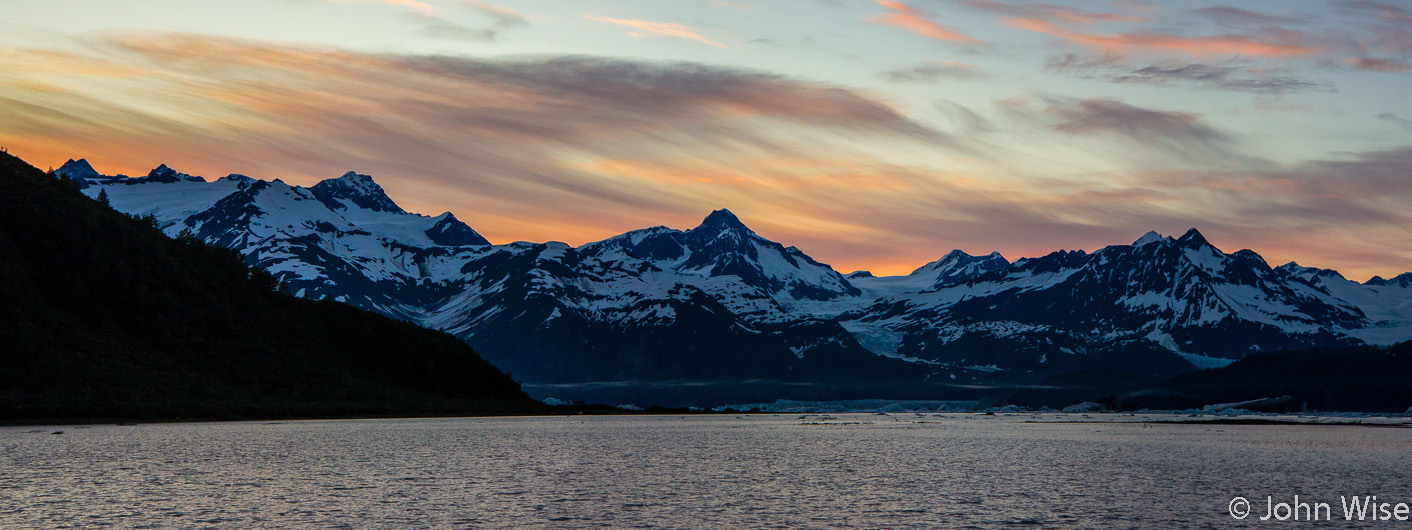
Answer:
top-left (0, 154), bottom-right (537, 421)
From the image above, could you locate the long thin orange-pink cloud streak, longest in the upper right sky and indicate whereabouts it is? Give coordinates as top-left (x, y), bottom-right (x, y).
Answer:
top-left (1005, 18), bottom-right (1315, 58)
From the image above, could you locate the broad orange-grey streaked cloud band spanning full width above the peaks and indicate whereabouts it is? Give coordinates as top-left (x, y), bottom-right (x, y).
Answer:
top-left (0, 34), bottom-right (1412, 282)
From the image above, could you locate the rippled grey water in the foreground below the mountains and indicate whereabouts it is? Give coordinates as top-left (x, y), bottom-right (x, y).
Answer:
top-left (0, 414), bottom-right (1412, 529)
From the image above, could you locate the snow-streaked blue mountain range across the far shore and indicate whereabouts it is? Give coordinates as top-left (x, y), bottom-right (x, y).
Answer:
top-left (58, 160), bottom-right (1412, 395)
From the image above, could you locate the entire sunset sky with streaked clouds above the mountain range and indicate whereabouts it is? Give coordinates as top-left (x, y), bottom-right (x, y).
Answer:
top-left (0, 0), bottom-right (1412, 281)
